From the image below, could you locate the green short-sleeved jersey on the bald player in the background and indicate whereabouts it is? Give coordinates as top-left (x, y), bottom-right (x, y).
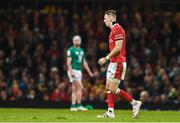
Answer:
top-left (67, 46), bottom-right (84, 70)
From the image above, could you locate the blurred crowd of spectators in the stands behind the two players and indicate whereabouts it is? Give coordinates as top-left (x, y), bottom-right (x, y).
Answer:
top-left (0, 1), bottom-right (180, 103)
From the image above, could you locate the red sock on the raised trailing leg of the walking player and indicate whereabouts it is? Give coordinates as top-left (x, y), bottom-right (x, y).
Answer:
top-left (116, 89), bottom-right (133, 102)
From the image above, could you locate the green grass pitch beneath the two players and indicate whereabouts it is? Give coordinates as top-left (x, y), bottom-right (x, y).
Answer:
top-left (0, 108), bottom-right (180, 122)
